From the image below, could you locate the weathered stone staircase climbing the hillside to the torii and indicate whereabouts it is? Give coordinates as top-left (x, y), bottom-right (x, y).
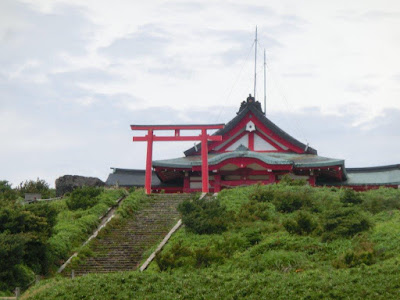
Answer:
top-left (69, 194), bottom-right (191, 276)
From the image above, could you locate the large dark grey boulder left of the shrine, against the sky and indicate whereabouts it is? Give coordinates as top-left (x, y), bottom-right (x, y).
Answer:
top-left (56, 175), bottom-right (105, 197)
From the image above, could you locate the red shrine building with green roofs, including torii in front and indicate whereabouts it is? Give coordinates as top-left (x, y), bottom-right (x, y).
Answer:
top-left (106, 95), bottom-right (400, 193)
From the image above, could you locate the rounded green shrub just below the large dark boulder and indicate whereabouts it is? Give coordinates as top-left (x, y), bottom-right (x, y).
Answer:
top-left (67, 186), bottom-right (103, 210)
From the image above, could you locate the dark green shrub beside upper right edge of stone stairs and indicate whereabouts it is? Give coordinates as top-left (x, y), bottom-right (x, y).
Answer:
top-left (178, 198), bottom-right (231, 234)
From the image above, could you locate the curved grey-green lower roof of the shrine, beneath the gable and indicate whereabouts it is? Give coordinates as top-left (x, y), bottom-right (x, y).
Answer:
top-left (153, 151), bottom-right (344, 168)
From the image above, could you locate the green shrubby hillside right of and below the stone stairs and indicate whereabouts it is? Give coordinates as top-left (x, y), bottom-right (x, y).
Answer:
top-left (23, 181), bottom-right (400, 299)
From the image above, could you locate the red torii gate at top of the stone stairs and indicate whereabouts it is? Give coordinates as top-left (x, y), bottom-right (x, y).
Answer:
top-left (131, 124), bottom-right (225, 194)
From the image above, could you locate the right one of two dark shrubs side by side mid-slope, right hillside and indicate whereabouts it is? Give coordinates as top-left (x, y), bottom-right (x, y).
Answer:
top-left (323, 207), bottom-right (372, 240)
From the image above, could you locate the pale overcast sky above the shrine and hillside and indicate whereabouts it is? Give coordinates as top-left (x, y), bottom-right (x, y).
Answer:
top-left (0, 0), bottom-right (400, 186)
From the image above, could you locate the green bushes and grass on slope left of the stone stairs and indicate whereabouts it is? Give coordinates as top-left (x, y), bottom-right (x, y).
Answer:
top-left (0, 179), bottom-right (123, 294)
